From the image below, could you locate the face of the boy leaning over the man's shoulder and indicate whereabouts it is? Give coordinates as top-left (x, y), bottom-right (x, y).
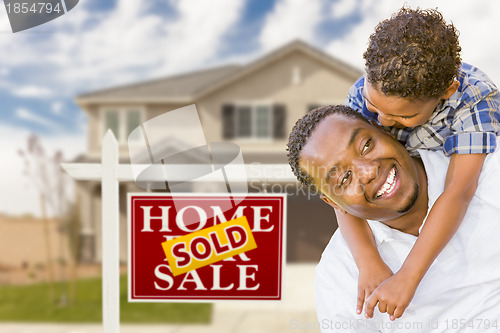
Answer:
top-left (363, 79), bottom-right (441, 128)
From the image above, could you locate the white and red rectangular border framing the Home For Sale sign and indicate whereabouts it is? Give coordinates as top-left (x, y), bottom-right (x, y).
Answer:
top-left (127, 192), bottom-right (287, 303)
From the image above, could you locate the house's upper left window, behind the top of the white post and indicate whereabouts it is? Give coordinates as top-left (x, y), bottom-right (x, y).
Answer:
top-left (101, 108), bottom-right (144, 143)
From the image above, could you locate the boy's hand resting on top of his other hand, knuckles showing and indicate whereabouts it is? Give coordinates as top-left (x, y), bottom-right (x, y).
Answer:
top-left (365, 271), bottom-right (418, 320)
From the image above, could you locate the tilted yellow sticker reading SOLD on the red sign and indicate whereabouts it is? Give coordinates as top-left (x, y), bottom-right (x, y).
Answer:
top-left (162, 216), bottom-right (257, 276)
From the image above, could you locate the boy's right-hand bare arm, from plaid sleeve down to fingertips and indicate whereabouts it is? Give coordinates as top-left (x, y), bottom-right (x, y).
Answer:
top-left (366, 154), bottom-right (486, 320)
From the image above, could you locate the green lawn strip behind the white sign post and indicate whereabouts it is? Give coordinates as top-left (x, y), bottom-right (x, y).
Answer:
top-left (0, 276), bottom-right (212, 323)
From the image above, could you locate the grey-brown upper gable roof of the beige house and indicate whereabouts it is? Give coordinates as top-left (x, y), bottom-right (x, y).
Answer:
top-left (75, 40), bottom-right (363, 105)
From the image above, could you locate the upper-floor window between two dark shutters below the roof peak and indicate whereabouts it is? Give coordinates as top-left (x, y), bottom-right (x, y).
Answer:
top-left (235, 105), bottom-right (272, 139)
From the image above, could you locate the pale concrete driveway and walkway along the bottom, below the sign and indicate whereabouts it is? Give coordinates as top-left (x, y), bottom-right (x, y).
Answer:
top-left (0, 264), bottom-right (319, 333)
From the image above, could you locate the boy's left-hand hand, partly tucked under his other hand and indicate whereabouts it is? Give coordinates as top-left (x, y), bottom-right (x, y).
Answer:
top-left (356, 261), bottom-right (393, 314)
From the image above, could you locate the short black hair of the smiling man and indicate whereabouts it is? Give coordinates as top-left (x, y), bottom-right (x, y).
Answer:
top-left (287, 105), bottom-right (368, 190)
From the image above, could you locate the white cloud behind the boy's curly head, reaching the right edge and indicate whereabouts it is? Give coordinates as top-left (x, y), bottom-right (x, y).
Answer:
top-left (326, 0), bottom-right (500, 85)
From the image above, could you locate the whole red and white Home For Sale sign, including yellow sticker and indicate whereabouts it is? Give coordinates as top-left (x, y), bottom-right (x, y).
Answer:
top-left (128, 193), bottom-right (286, 302)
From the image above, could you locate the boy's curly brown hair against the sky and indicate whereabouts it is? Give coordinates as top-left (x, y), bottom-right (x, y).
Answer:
top-left (363, 7), bottom-right (461, 100)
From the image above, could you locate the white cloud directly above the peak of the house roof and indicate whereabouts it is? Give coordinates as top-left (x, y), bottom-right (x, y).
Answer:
top-left (259, 0), bottom-right (324, 51)
